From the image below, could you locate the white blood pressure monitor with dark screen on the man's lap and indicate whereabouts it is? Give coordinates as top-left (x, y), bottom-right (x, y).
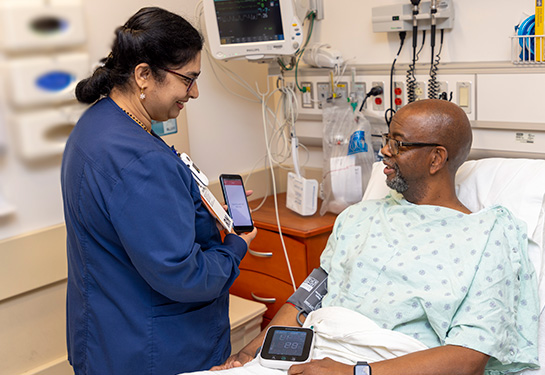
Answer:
top-left (259, 326), bottom-right (314, 370)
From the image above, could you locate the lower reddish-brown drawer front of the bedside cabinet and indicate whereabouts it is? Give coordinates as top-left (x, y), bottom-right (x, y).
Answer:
top-left (229, 270), bottom-right (293, 319)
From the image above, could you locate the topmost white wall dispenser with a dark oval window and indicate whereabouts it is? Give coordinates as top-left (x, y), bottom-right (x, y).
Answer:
top-left (0, 0), bottom-right (85, 52)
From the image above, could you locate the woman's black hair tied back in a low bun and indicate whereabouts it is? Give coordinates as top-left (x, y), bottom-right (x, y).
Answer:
top-left (76, 7), bottom-right (203, 104)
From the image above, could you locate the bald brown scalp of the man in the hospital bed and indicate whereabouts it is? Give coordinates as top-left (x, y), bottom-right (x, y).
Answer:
top-left (394, 99), bottom-right (473, 172)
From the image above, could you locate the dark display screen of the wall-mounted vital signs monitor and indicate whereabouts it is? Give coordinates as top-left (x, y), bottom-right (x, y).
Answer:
top-left (214, 0), bottom-right (285, 45)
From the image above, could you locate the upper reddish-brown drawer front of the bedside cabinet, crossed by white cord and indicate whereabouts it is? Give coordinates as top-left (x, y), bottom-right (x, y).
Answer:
top-left (244, 229), bottom-right (307, 285)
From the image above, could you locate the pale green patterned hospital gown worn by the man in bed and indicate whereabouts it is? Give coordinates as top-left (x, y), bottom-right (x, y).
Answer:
top-left (321, 191), bottom-right (539, 374)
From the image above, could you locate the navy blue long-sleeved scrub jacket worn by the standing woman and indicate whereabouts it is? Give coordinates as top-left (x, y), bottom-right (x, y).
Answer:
top-left (61, 98), bottom-right (247, 375)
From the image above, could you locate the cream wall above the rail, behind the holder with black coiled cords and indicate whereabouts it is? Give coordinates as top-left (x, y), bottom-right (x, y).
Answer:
top-left (313, 0), bottom-right (535, 64)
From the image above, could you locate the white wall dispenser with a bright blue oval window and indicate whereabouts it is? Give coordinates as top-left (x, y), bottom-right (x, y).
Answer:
top-left (6, 52), bottom-right (90, 107)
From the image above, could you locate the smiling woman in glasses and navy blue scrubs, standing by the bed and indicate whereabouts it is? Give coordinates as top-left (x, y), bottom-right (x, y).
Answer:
top-left (61, 8), bottom-right (256, 375)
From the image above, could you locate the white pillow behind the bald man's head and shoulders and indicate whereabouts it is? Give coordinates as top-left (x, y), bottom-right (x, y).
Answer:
top-left (363, 158), bottom-right (545, 310)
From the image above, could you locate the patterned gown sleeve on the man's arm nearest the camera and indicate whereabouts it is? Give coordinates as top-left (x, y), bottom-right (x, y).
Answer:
top-left (445, 207), bottom-right (539, 374)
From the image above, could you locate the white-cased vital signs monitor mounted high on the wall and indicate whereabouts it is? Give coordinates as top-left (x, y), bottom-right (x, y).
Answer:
top-left (203, 0), bottom-right (303, 60)
